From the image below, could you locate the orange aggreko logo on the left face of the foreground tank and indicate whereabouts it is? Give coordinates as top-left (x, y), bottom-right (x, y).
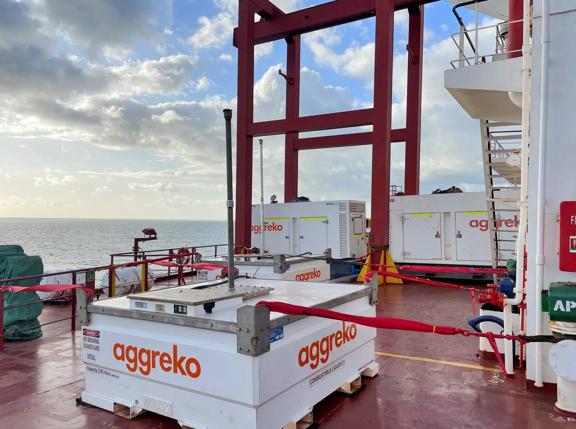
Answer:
top-left (112, 343), bottom-right (202, 378)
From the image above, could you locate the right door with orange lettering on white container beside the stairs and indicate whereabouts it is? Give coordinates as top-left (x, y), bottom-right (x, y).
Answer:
top-left (456, 211), bottom-right (492, 263)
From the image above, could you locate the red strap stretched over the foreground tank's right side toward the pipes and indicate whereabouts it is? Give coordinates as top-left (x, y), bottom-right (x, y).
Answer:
top-left (256, 301), bottom-right (526, 374)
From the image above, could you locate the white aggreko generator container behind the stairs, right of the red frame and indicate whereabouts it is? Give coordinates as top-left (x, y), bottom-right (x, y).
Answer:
top-left (390, 192), bottom-right (520, 266)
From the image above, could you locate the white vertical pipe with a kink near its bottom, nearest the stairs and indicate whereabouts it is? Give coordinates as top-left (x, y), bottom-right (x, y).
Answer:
top-left (504, 0), bottom-right (532, 374)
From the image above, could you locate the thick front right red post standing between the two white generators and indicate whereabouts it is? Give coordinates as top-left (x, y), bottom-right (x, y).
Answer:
top-left (371, 1), bottom-right (394, 263)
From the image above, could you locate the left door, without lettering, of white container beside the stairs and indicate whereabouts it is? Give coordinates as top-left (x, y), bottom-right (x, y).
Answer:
top-left (402, 213), bottom-right (442, 260)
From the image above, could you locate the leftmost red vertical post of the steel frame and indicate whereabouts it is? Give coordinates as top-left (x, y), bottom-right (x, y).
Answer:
top-left (235, 0), bottom-right (255, 247)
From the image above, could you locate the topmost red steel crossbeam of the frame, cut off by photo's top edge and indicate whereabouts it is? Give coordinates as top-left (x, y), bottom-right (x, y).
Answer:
top-left (234, 0), bottom-right (438, 46)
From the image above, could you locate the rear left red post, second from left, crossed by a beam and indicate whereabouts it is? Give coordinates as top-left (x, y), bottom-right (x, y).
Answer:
top-left (284, 35), bottom-right (300, 202)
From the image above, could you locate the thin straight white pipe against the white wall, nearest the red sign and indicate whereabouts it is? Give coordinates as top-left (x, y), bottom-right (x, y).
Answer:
top-left (533, 0), bottom-right (550, 387)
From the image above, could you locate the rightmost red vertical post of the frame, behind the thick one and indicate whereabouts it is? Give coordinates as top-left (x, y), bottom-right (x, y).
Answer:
top-left (404, 6), bottom-right (424, 195)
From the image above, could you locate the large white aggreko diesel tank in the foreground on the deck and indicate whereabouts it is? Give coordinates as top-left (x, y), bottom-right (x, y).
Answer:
top-left (80, 279), bottom-right (378, 429)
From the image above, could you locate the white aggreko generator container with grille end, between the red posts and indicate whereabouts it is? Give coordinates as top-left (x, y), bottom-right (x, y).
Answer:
top-left (251, 201), bottom-right (368, 258)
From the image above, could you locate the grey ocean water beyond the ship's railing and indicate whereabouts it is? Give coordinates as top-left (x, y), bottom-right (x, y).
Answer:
top-left (0, 218), bottom-right (226, 271)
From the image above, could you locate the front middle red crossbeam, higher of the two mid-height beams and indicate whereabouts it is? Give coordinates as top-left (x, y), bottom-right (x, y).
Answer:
top-left (248, 109), bottom-right (374, 137)
